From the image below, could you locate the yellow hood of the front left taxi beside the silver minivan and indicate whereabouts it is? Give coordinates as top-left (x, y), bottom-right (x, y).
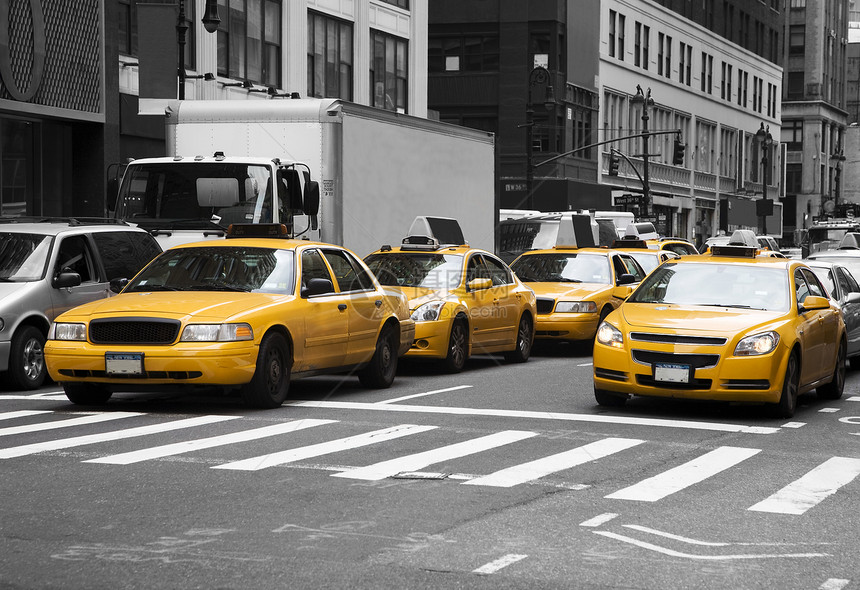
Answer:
top-left (55, 291), bottom-right (293, 321)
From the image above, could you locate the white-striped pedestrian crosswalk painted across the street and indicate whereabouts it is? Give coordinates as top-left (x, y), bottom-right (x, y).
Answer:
top-left (0, 410), bottom-right (860, 515)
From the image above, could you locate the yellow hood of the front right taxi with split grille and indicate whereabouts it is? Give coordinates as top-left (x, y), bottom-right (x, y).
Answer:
top-left (620, 302), bottom-right (785, 336)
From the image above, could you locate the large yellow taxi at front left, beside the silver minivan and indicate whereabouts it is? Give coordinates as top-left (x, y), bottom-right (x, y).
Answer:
top-left (45, 225), bottom-right (415, 408)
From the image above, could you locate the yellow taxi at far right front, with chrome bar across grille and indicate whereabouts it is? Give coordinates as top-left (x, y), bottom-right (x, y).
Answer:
top-left (594, 229), bottom-right (846, 418)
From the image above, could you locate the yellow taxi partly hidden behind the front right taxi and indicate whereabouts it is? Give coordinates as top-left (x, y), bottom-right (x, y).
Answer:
top-left (511, 217), bottom-right (646, 341)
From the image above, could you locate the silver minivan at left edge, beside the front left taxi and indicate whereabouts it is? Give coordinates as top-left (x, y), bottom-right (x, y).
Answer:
top-left (0, 217), bottom-right (161, 389)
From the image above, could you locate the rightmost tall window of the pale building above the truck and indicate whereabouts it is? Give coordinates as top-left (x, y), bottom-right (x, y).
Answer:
top-left (370, 30), bottom-right (409, 113)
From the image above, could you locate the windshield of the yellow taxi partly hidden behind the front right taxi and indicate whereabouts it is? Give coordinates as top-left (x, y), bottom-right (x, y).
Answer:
top-left (511, 252), bottom-right (611, 285)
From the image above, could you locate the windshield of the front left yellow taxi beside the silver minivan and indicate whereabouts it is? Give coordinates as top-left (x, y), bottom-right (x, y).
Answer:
top-left (123, 246), bottom-right (295, 294)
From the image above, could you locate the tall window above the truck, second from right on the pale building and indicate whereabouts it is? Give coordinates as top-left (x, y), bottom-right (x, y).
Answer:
top-left (307, 12), bottom-right (353, 100)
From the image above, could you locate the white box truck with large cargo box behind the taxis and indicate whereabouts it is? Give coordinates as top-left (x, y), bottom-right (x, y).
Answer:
top-left (109, 98), bottom-right (496, 256)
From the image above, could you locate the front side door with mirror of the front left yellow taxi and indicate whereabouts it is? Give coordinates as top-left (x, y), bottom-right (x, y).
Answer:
top-left (293, 248), bottom-right (349, 372)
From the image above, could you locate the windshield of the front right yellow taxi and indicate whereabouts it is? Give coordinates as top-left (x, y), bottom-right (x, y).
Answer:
top-left (627, 262), bottom-right (790, 311)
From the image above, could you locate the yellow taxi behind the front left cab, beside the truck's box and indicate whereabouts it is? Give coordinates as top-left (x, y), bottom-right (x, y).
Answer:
top-left (364, 217), bottom-right (535, 373)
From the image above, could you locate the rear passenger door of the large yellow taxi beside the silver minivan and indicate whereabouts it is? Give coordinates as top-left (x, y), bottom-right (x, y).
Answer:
top-left (323, 248), bottom-right (383, 365)
